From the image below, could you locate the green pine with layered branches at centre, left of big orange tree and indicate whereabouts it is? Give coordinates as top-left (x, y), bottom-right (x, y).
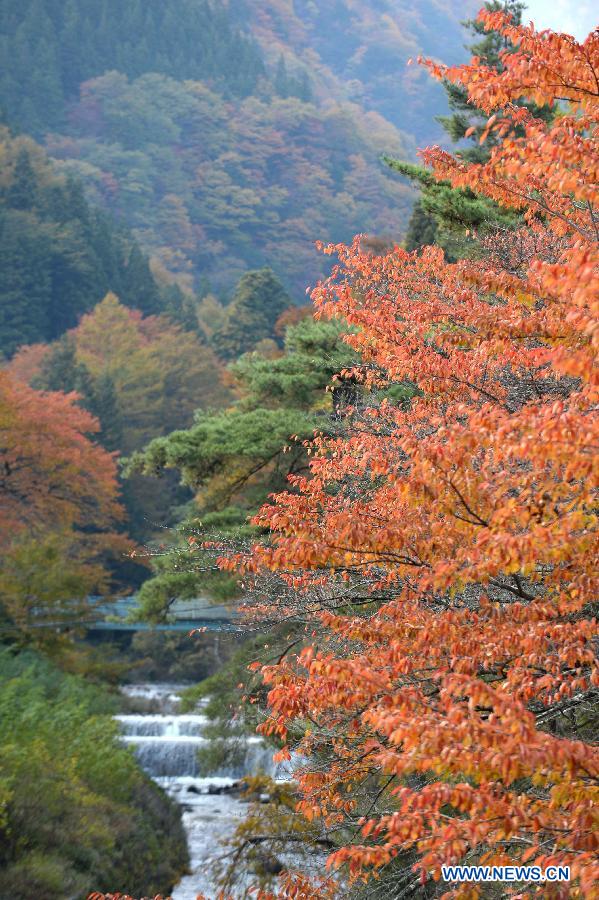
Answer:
top-left (129, 312), bottom-right (357, 618)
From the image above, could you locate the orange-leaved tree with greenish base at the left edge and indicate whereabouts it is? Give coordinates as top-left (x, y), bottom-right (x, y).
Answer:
top-left (0, 371), bottom-right (130, 640)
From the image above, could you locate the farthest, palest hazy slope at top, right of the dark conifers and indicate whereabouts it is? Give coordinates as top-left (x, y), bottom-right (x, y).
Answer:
top-left (231, 0), bottom-right (480, 141)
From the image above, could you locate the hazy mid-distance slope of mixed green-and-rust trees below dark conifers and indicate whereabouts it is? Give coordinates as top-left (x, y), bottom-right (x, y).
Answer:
top-left (48, 72), bottom-right (412, 300)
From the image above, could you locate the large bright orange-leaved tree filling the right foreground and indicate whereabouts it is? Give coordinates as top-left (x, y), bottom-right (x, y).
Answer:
top-left (222, 13), bottom-right (599, 897)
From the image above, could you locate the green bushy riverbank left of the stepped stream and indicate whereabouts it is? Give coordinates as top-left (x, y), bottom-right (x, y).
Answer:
top-left (0, 647), bottom-right (189, 900)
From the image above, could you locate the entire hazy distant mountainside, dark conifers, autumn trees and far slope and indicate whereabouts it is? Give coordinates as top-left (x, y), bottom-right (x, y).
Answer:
top-left (0, 0), bottom-right (476, 302)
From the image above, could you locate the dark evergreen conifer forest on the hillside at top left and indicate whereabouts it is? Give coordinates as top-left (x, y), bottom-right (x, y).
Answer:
top-left (0, 0), bottom-right (263, 136)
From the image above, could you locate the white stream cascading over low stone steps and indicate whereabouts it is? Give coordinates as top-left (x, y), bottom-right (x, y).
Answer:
top-left (116, 685), bottom-right (288, 900)
